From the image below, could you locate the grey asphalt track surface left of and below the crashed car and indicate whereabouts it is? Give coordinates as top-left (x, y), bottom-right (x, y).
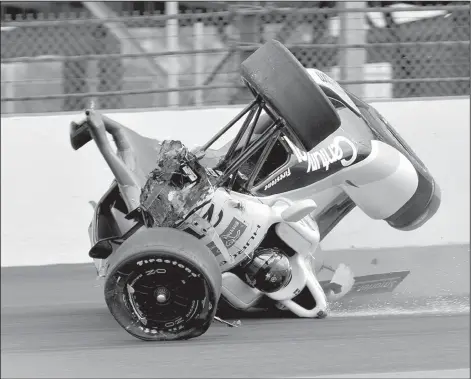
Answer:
top-left (1, 265), bottom-right (469, 378)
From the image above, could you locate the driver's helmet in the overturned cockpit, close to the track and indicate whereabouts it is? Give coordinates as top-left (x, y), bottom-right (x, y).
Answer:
top-left (244, 248), bottom-right (292, 293)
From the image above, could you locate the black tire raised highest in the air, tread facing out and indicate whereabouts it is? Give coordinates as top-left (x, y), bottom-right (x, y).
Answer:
top-left (241, 40), bottom-right (340, 151)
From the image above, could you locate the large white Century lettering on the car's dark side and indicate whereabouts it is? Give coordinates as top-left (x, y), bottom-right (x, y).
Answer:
top-left (285, 136), bottom-right (358, 173)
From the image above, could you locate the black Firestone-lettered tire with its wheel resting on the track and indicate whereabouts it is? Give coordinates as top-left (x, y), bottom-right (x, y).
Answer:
top-left (105, 228), bottom-right (222, 341)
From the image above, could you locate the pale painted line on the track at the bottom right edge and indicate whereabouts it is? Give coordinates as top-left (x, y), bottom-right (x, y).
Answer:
top-left (296, 368), bottom-right (470, 379)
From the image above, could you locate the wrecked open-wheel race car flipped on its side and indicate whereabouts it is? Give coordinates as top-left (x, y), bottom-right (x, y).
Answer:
top-left (70, 41), bottom-right (440, 341)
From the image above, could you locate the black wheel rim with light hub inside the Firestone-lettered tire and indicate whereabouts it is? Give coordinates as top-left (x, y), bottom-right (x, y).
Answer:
top-left (124, 256), bottom-right (209, 331)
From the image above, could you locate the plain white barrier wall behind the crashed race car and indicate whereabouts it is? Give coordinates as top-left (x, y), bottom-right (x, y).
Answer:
top-left (1, 99), bottom-right (469, 266)
